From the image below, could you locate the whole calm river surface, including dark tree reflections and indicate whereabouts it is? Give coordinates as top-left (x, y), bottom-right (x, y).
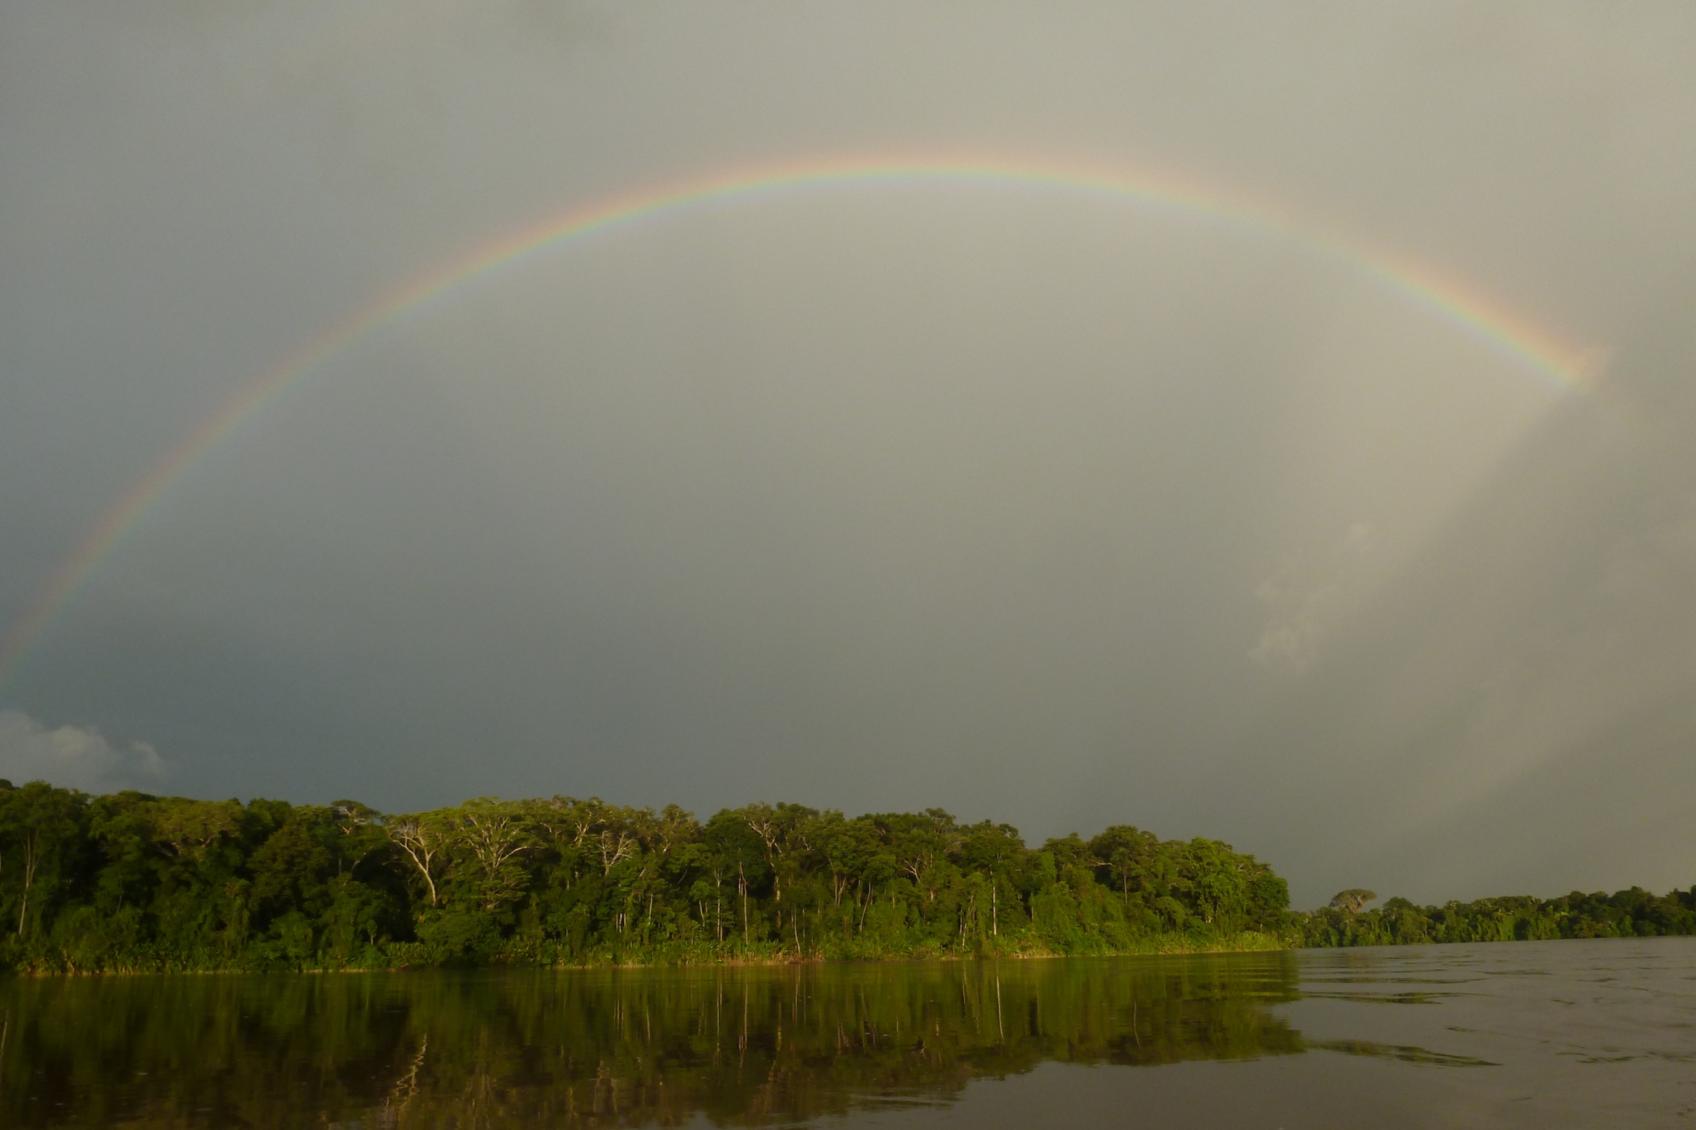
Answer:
top-left (0, 938), bottom-right (1696, 1128)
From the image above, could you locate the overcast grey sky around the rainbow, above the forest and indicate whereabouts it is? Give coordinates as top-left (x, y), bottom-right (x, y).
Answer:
top-left (0, 0), bottom-right (1696, 904)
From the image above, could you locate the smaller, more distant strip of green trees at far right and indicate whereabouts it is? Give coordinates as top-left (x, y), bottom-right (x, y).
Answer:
top-left (1301, 886), bottom-right (1696, 945)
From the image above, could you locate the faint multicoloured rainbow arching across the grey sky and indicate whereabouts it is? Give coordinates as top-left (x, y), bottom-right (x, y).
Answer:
top-left (0, 154), bottom-right (1591, 687)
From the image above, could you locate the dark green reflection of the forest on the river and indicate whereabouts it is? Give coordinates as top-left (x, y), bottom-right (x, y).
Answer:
top-left (0, 954), bottom-right (1301, 1125)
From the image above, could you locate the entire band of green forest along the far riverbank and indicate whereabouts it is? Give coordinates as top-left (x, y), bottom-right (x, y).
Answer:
top-left (0, 780), bottom-right (1696, 972)
